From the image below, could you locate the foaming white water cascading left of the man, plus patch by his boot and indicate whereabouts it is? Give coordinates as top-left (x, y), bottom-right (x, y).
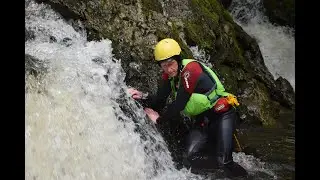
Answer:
top-left (25, 1), bottom-right (274, 180)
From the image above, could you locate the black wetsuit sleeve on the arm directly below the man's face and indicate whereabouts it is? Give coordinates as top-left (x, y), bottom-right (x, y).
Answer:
top-left (141, 79), bottom-right (171, 112)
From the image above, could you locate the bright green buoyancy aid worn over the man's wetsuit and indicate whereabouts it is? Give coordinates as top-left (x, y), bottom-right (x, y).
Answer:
top-left (169, 59), bottom-right (229, 116)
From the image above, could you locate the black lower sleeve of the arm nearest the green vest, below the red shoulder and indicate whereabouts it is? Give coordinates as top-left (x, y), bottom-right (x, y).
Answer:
top-left (157, 81), bottom-right (191, 123)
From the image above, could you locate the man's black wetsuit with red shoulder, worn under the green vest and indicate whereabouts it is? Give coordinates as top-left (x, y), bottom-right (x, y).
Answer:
top-left (145, 62), bottom-right (248, 177)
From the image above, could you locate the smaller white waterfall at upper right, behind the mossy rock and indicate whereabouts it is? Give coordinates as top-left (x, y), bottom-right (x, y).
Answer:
top-left (230, 0), bottom-right (295, 89)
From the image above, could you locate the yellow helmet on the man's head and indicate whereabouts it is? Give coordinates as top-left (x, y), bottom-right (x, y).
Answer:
top-left (154, 38), bottom-right (181, 61)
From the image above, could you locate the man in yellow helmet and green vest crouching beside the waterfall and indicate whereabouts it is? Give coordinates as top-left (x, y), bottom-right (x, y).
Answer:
top-left (129, 38), bottom-right (247, 177)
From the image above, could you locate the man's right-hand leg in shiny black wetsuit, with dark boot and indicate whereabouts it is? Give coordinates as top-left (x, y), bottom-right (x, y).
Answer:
top-left (210, 109), bottom-right (247, 177)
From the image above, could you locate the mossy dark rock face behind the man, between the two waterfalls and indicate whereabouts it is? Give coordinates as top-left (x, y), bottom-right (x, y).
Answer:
top-left (26, 0), bottom-right (295, 170)
